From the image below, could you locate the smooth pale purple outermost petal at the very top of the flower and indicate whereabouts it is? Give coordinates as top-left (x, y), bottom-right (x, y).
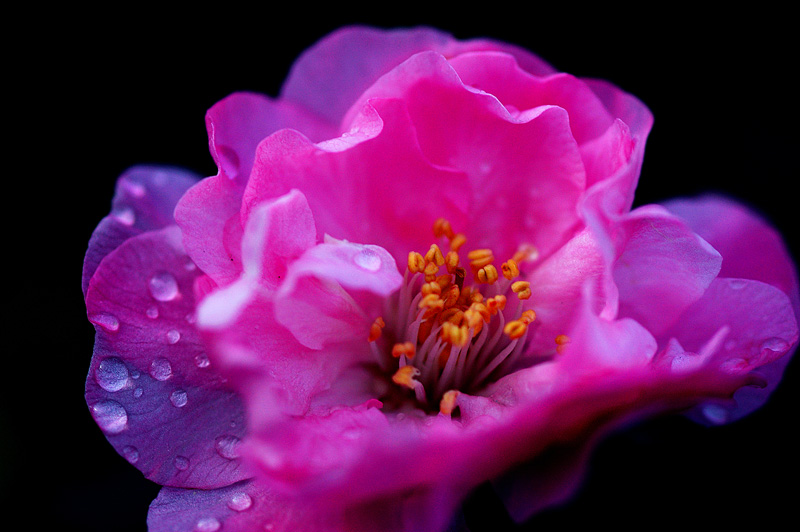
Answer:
top-left (281, 27), bottom-right (553, 128)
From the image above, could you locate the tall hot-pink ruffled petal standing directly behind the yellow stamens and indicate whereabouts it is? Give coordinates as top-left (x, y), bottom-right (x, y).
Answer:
top-left (345, 52), bottom-right (585, 257)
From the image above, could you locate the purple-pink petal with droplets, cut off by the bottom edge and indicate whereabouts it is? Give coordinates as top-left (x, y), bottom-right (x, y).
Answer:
top-left (147, 480), bottom-right (345, 532)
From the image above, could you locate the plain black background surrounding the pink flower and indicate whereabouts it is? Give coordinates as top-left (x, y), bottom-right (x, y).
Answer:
top-left (10, 4), bottom-right (800, 532)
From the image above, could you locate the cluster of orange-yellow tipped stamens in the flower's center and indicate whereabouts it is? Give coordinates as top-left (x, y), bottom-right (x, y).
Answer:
top-left (368, 219), bottom-right (566, 415)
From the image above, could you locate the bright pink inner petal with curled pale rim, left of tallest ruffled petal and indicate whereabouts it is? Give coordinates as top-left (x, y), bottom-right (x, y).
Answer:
top-left (243, 96), bottom-right (468, 263)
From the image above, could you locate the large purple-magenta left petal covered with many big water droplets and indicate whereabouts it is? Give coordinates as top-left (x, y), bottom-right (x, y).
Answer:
top-left (86, 226), bottom-right (244, 488)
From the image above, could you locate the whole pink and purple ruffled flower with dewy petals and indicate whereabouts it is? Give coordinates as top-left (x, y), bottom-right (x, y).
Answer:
top-left (83, 28), bottom-right (800, 532)
